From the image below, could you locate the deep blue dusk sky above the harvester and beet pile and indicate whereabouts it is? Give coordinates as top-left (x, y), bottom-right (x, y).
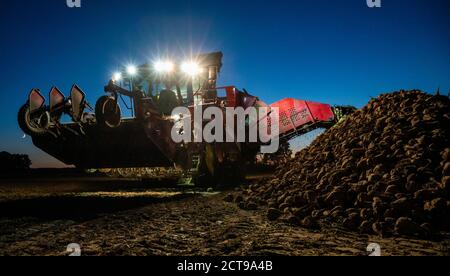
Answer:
top-left (0, 0), bottom-right (450, 166)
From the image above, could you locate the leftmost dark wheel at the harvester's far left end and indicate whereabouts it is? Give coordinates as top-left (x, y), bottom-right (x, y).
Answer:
top-left (17, 103), bottom-right (50, 136)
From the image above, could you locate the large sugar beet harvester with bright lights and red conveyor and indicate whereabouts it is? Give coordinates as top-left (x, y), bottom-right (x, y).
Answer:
top-left (18, 52), bottom-right (353, 182)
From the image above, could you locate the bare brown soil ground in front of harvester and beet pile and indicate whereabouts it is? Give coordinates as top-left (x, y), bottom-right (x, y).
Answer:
top-left (0, 178), bottom-right (450, 256)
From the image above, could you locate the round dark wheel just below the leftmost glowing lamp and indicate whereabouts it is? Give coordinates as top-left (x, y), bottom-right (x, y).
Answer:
top-left (95, 96), bottom-right (122, 128)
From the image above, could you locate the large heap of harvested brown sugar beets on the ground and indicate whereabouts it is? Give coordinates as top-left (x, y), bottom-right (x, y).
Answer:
top-left (234, 90), bottom-right (450, 238)
